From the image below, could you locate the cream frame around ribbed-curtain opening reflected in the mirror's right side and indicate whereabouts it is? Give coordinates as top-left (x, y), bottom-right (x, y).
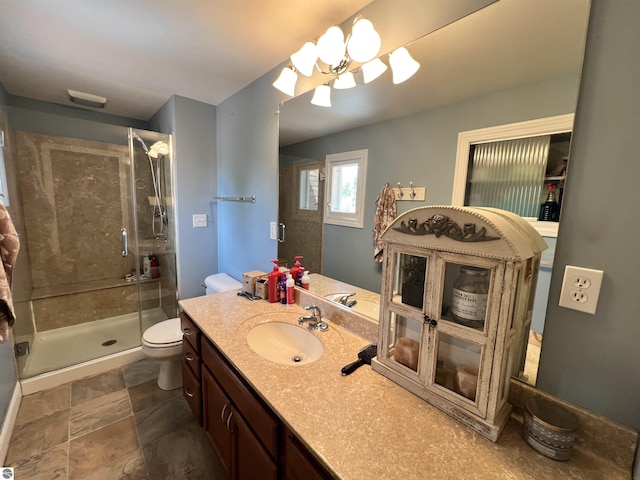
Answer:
top-left (451, 113), bottom-right (575, 237)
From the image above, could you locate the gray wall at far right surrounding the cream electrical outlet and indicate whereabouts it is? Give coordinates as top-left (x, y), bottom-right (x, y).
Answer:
top-left (538, 0), bottom-right (640, 429)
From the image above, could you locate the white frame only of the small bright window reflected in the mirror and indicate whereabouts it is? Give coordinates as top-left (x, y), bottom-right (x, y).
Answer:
top-left (323, 149), bottom-right (369, 228)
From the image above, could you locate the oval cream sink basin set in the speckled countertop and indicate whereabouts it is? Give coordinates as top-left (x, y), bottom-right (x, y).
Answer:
top-left (247, 322), bottom-right (324, 365)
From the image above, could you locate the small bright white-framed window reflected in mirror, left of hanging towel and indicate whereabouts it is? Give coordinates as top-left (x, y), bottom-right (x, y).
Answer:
top-left (324, 150), bottom-right (368, 228)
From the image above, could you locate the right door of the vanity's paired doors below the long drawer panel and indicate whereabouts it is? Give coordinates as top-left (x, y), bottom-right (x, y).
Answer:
top-left (230, 411), bottom-right (278, 480)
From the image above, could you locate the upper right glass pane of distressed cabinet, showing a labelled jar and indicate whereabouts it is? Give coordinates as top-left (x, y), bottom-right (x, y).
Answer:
top-left (442, 262), bottom-right (491, 330)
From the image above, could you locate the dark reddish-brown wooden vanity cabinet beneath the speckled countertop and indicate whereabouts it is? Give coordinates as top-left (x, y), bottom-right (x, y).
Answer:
top-left (180, 312), bottom-right (335, 480)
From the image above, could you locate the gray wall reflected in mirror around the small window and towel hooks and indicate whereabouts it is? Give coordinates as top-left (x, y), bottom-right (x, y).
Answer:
top-left (282, 76), bottom-right (579, 292)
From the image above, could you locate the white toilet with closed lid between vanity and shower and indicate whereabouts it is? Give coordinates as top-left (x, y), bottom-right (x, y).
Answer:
top-left (142, 273), bottom-right (242, 390)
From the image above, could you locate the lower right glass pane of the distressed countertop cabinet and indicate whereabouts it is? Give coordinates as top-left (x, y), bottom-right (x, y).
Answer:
top-left (435, 332), bottom-right (482, 402)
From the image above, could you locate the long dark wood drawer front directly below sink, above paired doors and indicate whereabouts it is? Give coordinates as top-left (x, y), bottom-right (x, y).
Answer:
top-left (202, 337), bottom-right (278, 458)
